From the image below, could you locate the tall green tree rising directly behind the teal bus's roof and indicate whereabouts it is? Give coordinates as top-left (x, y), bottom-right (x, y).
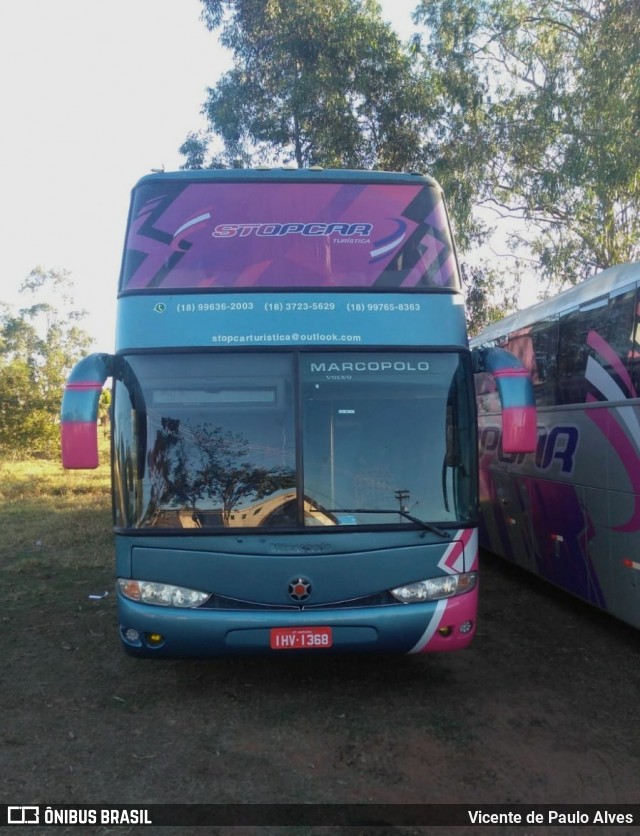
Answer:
top-left (181, 0), bottom-right (430, 170)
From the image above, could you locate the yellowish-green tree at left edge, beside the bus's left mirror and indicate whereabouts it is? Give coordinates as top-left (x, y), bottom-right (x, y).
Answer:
top-left (0, 267), bottom-right (92, 457)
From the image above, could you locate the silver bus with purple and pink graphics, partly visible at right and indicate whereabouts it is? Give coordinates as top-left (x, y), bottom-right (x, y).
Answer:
top-left (472, 263), bottom-right (640, 627)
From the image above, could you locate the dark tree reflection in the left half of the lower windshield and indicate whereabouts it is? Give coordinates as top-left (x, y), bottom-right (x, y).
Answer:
top-left (147, 418), bottom-right (295, 525)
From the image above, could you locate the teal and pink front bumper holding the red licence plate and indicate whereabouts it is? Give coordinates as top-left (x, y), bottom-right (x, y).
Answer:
top-left (118, 588), bottom-right (478, 659)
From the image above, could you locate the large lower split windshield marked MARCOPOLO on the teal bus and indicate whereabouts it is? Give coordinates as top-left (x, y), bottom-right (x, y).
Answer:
top-left (114, 352), bottom-right (476, 530)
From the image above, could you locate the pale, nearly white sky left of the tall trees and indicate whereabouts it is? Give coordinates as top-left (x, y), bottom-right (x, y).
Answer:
top-left (0, 0), bottom-right (436, 351)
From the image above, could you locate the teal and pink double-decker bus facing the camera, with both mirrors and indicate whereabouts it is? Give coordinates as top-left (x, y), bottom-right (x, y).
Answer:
top-left (61, 169), bottom-right (535, 658)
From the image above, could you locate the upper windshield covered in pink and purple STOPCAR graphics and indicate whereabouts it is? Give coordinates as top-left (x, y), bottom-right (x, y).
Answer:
top-left (120, 174), bottom-right (460, 293)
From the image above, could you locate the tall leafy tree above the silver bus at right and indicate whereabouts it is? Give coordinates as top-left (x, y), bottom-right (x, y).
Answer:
top-left (415, 0), bottom-right (640, 287)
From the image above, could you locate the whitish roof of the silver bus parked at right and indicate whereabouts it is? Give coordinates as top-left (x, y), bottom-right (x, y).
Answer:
top-left (471, 261), bottom-right (640, 345)
